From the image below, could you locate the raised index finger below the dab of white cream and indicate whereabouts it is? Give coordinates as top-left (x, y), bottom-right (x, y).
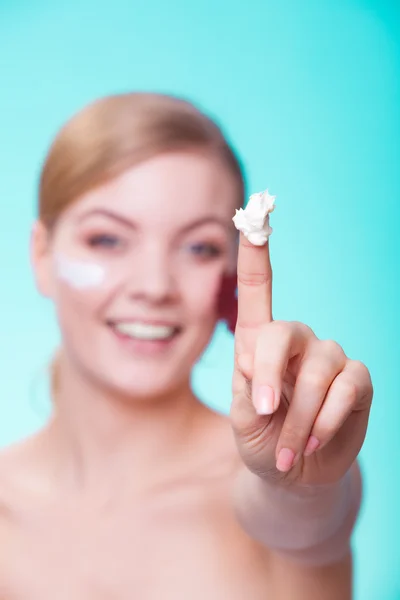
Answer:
top-left (237, 233), bottom-right (272, 329)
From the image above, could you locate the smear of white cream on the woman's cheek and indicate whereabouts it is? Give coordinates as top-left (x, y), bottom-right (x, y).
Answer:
top-left (55, 255), bottom-right (106, 290)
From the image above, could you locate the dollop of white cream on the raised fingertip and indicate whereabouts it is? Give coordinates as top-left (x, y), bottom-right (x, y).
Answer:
top-left (232, 190), bottom-right (275, 246)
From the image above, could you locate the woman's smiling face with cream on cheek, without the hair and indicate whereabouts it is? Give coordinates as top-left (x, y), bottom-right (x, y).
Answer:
top-left (33, 153), bottom-right (237, 397)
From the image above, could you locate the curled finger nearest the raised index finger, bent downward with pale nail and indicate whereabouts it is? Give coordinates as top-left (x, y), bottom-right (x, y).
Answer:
top-left (252, 321), bottom-right (313, 415)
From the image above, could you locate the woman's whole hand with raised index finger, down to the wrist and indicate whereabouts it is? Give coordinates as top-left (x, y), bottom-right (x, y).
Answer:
top-left (231, 234), bottom-right (373, 484)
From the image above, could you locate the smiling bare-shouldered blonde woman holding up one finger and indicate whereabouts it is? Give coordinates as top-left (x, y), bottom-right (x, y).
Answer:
top-left (0, 94), bottom-right (372, 600)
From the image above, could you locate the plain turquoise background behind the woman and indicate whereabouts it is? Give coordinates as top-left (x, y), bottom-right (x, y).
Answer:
top-left (0, 0), bottom-right (400, 600)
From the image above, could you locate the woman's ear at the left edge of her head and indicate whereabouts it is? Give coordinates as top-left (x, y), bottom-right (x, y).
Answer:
top-left (30, 221), bottom-right (53, 298)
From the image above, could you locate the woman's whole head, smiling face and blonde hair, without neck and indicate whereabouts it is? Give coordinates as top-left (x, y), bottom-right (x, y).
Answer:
top-left (33, 94), bottom-right (243, 404)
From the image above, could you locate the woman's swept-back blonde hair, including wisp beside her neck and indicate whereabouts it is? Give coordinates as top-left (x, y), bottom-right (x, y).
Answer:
top-left (38, 92), bottom-right (245, 399)
